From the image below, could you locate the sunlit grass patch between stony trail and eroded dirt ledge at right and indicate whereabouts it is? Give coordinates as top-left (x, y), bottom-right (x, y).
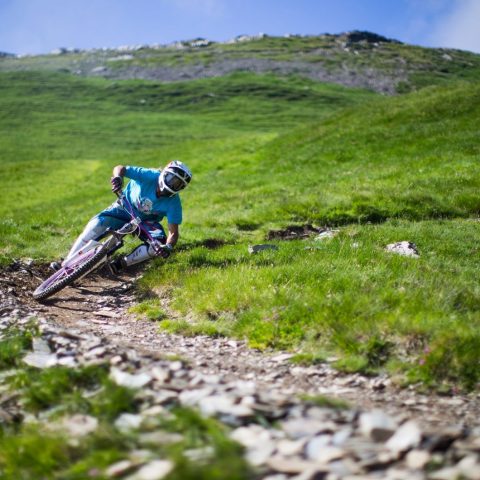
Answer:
top-left (142, 220), bottom-right (480, 388)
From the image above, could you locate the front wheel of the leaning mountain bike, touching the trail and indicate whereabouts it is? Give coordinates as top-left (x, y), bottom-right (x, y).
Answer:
top-left (33, 244), bottom-right (109, 301)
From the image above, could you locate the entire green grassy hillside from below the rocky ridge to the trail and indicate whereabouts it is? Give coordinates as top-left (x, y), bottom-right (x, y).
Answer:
top-left (0, 65), bottom-right (480, 388)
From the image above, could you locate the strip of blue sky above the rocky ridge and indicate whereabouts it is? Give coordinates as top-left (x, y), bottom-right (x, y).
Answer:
top-left (0, 0), bottom-right (480, 54)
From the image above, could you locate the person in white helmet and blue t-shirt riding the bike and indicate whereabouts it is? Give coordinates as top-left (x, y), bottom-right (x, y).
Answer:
top-left (51, 160), bottom-right (192, 273)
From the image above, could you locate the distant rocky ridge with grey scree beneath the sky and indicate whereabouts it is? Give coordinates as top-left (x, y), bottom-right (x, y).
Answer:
top-left (0, 30), bottom-right (480, 95)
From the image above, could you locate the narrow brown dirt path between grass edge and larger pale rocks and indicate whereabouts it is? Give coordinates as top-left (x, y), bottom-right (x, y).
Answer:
top-left (0, 263), bottom-right (480, 430)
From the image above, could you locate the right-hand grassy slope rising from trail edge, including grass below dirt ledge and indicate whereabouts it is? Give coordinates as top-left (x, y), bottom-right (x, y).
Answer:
top-left (136, 84), bottom-right (480, 388)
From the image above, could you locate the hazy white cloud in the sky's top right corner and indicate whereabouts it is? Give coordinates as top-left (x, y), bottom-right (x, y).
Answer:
top-left (430, 0), bottom-right (480, 53)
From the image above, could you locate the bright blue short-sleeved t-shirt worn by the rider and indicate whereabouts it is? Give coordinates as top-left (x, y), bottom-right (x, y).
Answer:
top-left (125, 166), bottom-right (182, 224)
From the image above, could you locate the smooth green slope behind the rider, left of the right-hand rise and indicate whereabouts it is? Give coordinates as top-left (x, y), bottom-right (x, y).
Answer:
top-left (0, 72), bottom-right (374, 261)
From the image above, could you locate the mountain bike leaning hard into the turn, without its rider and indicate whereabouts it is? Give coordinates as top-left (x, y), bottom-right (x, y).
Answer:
top-left (33, 191), bottom-right (161, 301)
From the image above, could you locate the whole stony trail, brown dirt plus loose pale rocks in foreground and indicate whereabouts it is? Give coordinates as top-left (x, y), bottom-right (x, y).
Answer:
top-left (0, 263), bottom-right (480, 480)
